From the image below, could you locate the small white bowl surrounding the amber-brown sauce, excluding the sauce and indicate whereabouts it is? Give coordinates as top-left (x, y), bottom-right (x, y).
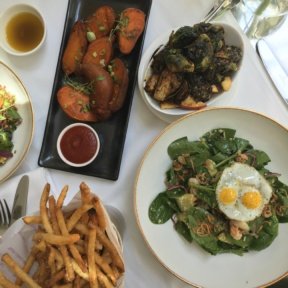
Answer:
top-left (0, 4), bottom-right (46, 56)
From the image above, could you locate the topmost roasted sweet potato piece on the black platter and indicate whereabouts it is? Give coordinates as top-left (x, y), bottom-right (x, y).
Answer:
top-left (85, 5), bottom-right (117, 39)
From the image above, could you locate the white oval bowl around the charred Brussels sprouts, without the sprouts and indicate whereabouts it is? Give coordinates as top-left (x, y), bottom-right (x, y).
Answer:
top-left (138, 21), bottom-right (244, 122)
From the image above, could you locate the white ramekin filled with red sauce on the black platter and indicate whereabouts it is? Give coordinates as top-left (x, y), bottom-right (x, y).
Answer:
top-left (57, 123), bottom-right (100, 167)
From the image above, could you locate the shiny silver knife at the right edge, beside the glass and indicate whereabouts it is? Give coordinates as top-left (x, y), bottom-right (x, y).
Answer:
top-left (256, 39), bottom-right (288, 104)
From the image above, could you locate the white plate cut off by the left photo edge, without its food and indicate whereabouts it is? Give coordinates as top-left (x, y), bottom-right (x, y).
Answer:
top-left (0, 62), bottom-right (34, 183)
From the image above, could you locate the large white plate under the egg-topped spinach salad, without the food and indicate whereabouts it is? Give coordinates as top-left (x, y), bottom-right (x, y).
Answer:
top-left (134, 107), bottom-right (288, 288)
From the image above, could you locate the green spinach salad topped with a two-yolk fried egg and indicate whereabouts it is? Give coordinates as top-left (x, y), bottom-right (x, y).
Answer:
top-left (148, 128), bottom-right (288, 255)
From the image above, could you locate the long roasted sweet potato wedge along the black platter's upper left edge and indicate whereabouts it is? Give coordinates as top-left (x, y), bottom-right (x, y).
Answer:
top-left (62, 21), bottom-right (88, 75)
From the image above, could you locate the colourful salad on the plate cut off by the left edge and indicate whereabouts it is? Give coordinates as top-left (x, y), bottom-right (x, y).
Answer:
top-left (0, 85), bottom-right (22, 166)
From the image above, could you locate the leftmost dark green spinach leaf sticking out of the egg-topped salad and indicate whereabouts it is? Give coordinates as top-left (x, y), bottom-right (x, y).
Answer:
top-left (148, 192), bottom-right (179, 224)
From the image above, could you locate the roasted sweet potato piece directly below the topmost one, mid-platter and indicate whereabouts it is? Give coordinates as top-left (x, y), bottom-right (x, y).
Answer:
top-left (82, 37), bottom-right (113, 67)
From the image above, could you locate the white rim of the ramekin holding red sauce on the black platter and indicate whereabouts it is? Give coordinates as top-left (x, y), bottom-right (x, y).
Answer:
top-left (57, 123), bottom-right (100, 167)
